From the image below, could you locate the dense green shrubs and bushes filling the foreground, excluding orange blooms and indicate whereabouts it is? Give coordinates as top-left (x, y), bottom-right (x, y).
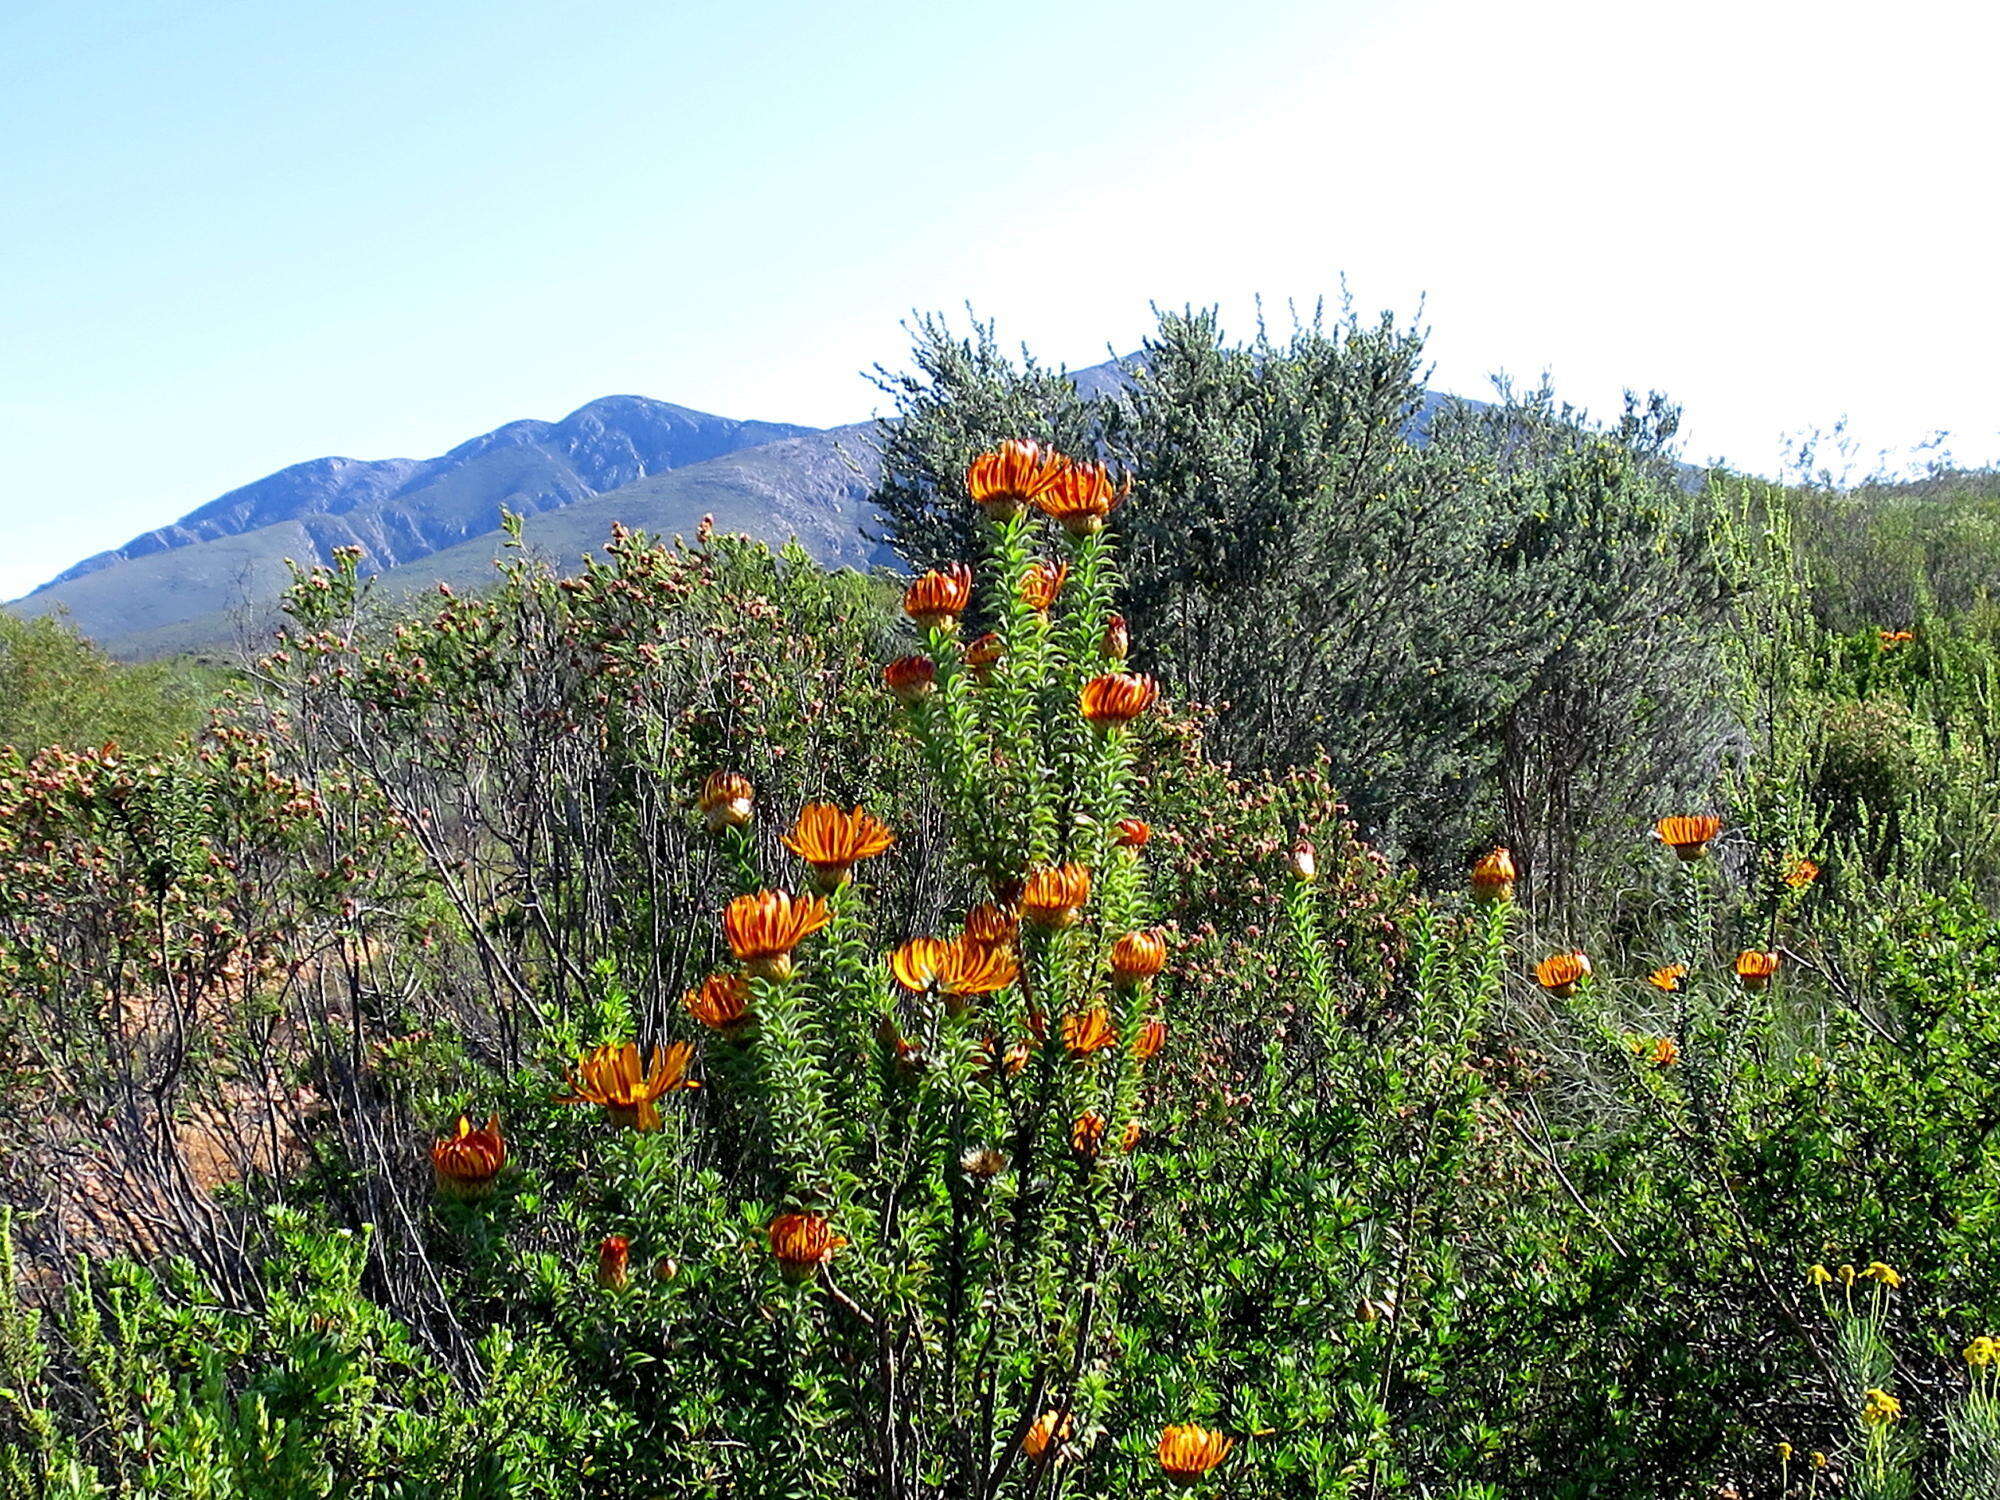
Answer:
top-left (0, 316), bottom-right (2000, 1500)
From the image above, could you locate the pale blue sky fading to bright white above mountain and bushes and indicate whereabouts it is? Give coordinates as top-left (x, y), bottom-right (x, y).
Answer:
top-left (0, 0), bottom-right (2000, 598)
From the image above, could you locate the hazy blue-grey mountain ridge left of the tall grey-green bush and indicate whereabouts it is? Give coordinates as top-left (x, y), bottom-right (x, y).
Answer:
top-left (8, 396), bottom-right (872, 658)
